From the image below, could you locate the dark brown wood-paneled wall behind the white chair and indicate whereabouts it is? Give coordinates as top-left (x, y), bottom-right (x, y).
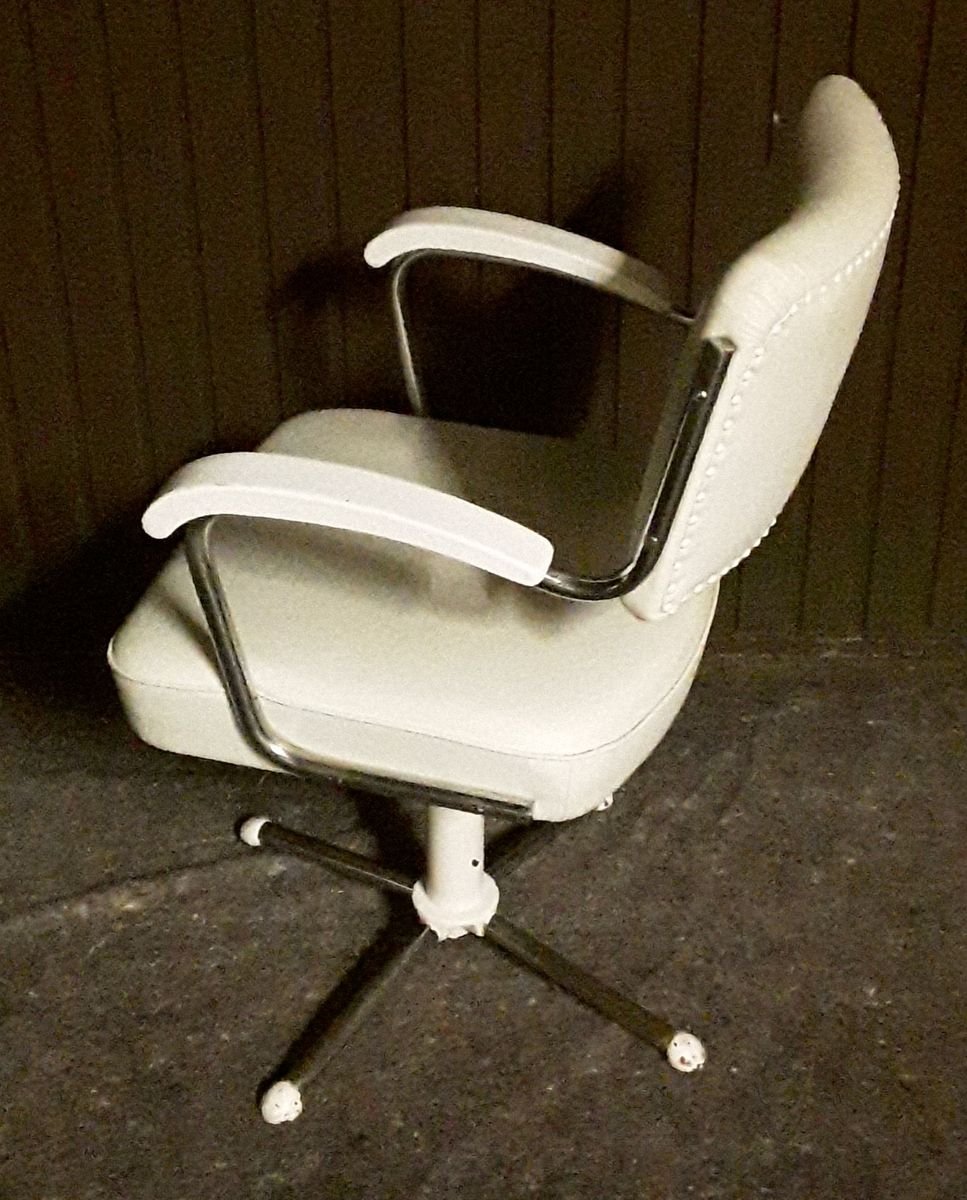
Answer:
top-left (0, 0), bottom-right (967, 638)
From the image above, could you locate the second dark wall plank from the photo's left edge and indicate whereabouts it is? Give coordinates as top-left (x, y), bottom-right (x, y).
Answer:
top-left (29, 0), bottom-right (154, 523)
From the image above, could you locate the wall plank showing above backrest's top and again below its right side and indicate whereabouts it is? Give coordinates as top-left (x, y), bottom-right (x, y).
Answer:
top-left (739, 0), bottom-right (853, 636)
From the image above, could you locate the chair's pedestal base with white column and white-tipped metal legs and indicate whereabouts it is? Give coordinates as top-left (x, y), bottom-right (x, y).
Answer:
top-left (240, 806), bottom-right (705, 1124)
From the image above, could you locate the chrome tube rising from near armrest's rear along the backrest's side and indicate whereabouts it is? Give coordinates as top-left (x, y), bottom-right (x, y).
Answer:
top-left (537, 337), bottom-right (735, 600)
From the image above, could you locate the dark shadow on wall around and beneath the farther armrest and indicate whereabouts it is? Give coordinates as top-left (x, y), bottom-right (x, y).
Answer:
top-left (271, 172), bottom-right (624, 436)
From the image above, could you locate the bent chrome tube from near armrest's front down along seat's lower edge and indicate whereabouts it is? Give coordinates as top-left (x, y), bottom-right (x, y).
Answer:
top-left (185, 516), bottom-right (531, 823)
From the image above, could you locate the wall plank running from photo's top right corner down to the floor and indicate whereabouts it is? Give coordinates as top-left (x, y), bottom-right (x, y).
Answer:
top-left (869, 0), bottom-right (967, 636)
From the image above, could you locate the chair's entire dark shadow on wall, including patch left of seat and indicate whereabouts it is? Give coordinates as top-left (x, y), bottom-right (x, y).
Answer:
top-left (0, 175), bottom-right (623, 713)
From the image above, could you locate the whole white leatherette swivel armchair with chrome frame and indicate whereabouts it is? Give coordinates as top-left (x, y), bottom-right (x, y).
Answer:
top-left (109, 77), bottom-right (899, 1122)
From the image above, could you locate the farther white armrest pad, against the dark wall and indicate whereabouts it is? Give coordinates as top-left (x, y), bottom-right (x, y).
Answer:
top-left (364, 208), bottom-right (672, 313)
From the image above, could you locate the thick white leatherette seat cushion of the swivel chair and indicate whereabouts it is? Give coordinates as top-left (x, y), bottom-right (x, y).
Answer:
top-left (109, 409), bottom-right (715, 821)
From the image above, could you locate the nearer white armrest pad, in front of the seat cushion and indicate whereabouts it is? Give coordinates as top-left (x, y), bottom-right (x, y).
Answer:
top-left (142, 452), bottom-right (554, 586)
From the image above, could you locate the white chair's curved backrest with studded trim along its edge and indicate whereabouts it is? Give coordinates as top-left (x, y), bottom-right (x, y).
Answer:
top-left (624, 76), bottom-right (899, 619)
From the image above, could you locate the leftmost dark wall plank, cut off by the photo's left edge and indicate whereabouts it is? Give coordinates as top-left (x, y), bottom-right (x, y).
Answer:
top-left (0, 5), bottom-right (92, 574)
